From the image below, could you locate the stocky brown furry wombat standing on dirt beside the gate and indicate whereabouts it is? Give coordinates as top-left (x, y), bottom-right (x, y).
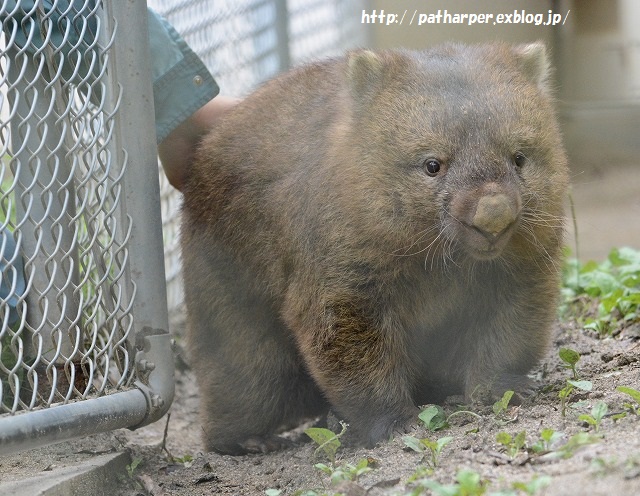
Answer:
top-left (181, 44), bottom-right (568, 454)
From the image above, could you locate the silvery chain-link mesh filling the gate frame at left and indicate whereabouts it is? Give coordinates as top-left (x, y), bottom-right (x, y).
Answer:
top-left (0, 1), bottom-right (135, 414)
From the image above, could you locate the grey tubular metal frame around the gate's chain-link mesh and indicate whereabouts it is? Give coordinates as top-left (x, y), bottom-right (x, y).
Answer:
top-left (0, 0), bottom-right (175, 455)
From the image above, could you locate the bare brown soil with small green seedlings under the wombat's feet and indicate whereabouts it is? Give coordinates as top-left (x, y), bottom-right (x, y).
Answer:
top-left (119, 318), bottom-right (640, 496)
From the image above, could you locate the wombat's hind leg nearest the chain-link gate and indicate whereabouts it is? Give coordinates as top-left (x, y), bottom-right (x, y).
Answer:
top-left (185, 247), bottom-right (326, 454)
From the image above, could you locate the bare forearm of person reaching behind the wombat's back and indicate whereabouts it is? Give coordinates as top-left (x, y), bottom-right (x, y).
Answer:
top-left (158, 96), bottom-right (240, 191)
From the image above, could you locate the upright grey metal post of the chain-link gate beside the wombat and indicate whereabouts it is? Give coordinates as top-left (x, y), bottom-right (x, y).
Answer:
top-left (105, 0), bottom-right (174, 423)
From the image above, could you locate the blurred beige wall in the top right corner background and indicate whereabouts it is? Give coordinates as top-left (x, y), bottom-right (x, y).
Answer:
top-left (558, 0), bottom-right (640, 173)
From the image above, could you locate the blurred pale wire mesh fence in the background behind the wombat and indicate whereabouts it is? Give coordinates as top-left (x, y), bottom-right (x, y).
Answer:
top-left (148, 0), bottom-right (366, 322)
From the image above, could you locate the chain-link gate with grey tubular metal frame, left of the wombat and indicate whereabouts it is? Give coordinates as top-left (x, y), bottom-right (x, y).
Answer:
top-left (0, 0), bottom-right (174, 454)
